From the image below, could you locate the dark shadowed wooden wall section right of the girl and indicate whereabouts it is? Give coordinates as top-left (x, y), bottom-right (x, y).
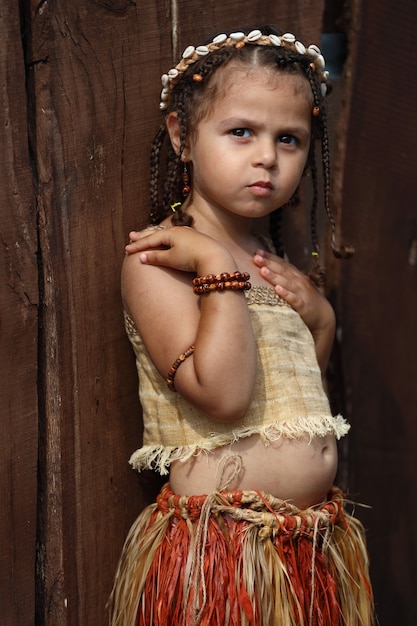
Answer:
top-left (337, 0), bottom-right (417, 626)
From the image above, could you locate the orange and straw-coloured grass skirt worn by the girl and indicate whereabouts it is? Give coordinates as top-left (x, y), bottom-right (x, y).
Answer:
top-left (110, 484), bottom-right (373, 626)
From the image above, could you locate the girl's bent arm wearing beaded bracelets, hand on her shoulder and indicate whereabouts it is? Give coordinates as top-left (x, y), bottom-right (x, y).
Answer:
top-left (122, 226), bottom-right (256, 421)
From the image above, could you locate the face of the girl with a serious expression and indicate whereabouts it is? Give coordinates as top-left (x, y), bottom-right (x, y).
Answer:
top-left (184, 66), bottom-right (313, 218)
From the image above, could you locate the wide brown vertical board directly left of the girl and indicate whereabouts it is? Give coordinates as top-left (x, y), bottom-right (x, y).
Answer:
top-left (27, 2), bottom-right (171, 626)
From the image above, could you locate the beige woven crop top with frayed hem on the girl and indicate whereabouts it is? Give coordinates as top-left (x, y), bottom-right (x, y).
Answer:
top-left (125, 287), bottom-right (350, 474)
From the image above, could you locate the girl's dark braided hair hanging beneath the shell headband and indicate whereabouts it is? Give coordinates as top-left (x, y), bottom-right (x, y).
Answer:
top-left (150, 26), bottom-right (353, 285)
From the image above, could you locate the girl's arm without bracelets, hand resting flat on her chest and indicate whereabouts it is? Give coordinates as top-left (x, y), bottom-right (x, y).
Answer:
top-left (250, 250), bottom-right (336, 376)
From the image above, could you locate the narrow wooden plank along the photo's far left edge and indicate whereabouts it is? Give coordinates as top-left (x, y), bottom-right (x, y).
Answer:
top-left (0, 0), bottom-right (38, 626)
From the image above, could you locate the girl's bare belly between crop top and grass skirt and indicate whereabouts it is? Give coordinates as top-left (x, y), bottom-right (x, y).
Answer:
top-left (170, 435), bottom-right (337, 508)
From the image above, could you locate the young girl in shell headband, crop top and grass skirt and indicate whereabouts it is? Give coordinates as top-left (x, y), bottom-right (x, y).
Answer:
top-left (111, 28), bottom-right (372, 626)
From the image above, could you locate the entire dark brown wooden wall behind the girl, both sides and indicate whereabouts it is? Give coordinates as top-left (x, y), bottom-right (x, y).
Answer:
top-left (0, 0), bottom-right (417, 626)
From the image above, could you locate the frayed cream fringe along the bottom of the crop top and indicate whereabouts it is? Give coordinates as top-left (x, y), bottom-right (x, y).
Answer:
top-left (129, 415), bottom-right (350, 476)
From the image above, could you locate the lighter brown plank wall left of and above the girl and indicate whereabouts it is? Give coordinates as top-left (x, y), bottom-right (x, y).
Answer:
top-left (0, 0), bottom-right (323, 626)
